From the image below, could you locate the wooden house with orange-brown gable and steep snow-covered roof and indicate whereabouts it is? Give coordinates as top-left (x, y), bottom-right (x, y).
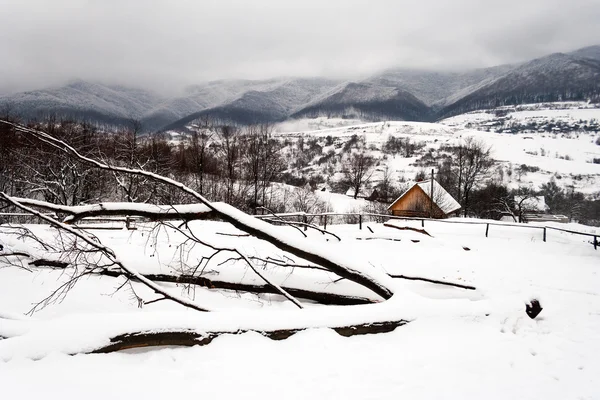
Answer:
top-left (388, 179), bottom-right (460, 218)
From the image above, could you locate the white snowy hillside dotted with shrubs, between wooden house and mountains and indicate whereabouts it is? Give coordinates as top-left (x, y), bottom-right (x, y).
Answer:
top-left (277, 102), bottom-right (600, 194)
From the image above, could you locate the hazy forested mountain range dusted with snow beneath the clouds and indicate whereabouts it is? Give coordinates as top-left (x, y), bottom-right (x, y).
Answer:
top-left (0, 46), bottom-right (600, 131)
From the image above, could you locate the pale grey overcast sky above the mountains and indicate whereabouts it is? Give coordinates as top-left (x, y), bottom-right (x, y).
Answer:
top-left (0, 0), bottom-right (600, 93)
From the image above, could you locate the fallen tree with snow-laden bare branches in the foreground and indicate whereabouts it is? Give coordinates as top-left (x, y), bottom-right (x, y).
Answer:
top-left (0, 117), bottom-right (470, 354)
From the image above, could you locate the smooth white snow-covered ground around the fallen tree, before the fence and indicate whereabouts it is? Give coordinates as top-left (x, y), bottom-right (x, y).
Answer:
top-left (0, 217), bottom-right (600, 400)
